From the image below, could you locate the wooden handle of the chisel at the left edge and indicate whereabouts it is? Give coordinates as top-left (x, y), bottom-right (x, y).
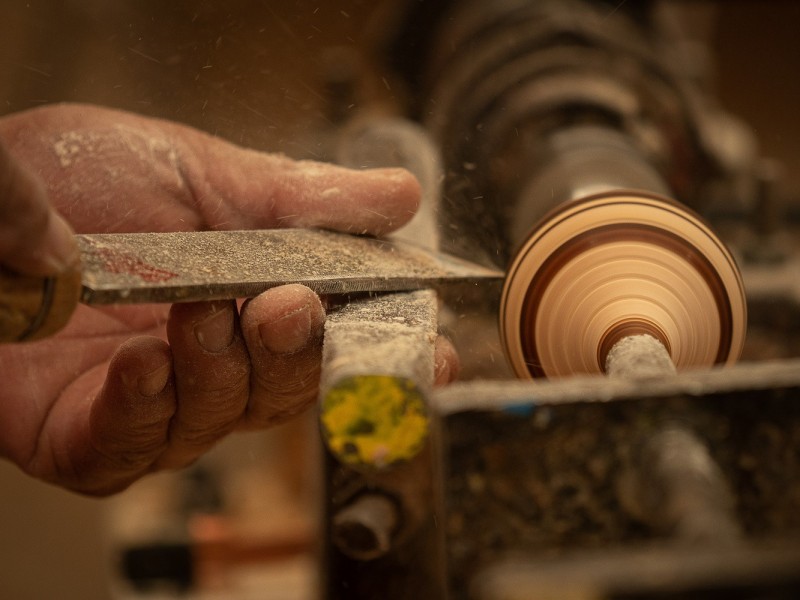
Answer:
top-left (0, 266), bottom-right (81, 342)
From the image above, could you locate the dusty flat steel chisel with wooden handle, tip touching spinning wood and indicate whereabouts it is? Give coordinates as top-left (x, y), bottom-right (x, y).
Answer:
top-left (0, 229), bottom-right (503, 342)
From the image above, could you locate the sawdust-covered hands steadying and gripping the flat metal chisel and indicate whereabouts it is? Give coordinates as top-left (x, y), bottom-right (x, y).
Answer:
top-left (0, 105), bottom-right (457, 495)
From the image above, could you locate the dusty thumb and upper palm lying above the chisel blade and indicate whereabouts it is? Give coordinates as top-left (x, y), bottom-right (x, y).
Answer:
top-left (0, 105), bottom-right (421, 235)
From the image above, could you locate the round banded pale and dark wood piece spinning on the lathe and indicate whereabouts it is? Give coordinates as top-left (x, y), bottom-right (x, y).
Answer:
top-left (500, 192), bottom-right (747, 378)
